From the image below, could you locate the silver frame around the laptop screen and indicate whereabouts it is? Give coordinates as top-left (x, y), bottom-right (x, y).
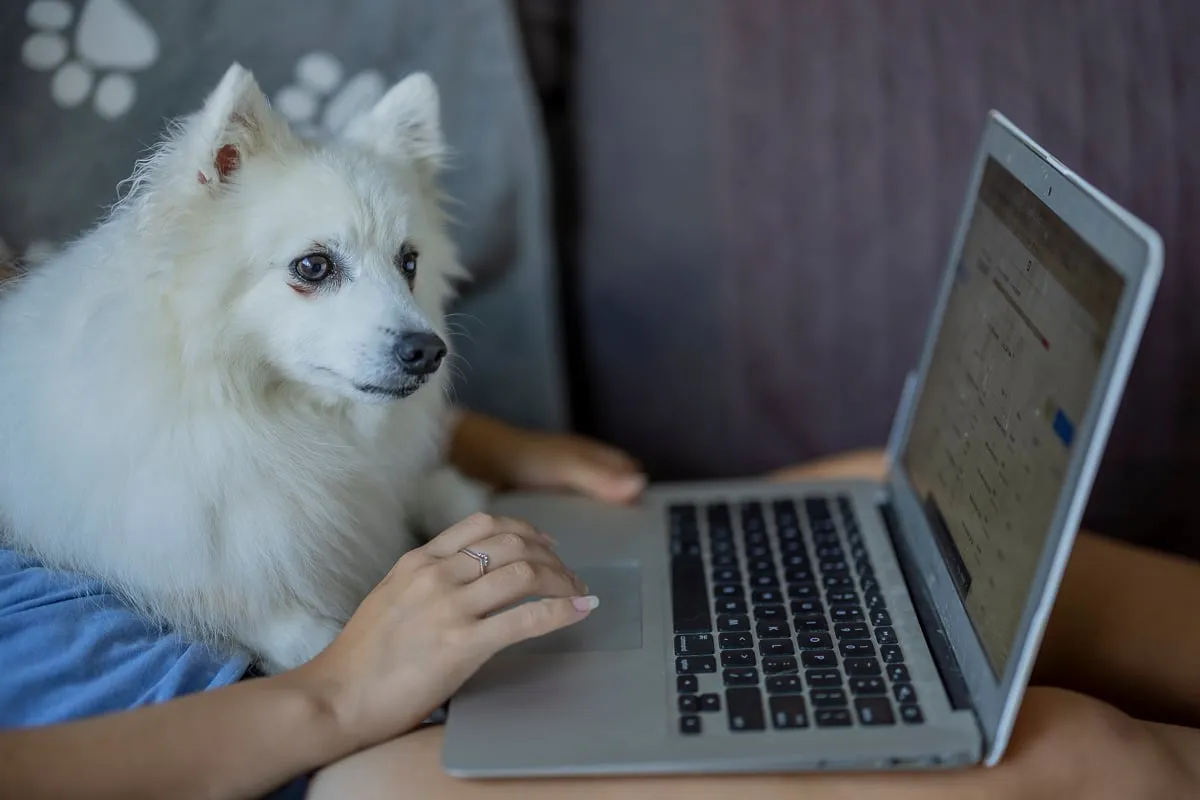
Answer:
top-left (888, 112), bottom-right (1163, 765)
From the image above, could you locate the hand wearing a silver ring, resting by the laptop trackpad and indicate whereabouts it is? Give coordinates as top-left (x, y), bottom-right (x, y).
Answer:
top-left (295, 515), bottom-right (599, 748)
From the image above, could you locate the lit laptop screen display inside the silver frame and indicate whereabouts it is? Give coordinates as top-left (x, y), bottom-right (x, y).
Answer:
top-left (901, 158), bottom-right (1124, 675)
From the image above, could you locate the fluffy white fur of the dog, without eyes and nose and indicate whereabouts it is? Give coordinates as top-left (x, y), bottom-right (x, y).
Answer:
top-left (0, 65), bottom-right (485, 670)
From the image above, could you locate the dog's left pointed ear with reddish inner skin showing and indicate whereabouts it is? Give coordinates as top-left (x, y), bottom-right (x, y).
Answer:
top-left (187, 64), bottom-right (274, 184)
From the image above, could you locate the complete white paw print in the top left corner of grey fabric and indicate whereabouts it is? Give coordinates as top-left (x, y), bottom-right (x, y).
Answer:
top-left (20, 0), bottom-right (158, 120)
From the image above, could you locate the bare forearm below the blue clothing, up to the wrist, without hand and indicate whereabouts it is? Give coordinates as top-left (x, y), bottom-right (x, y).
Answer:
top-left (0, 672), bottom-right (354, 799)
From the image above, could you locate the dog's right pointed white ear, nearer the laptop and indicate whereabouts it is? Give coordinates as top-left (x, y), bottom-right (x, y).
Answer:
top-left (344, 72), bottom-right (446, 172)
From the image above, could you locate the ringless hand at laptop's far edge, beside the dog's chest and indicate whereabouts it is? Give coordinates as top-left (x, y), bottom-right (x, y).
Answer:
top-left (450, 414), bottom-right (646, 504)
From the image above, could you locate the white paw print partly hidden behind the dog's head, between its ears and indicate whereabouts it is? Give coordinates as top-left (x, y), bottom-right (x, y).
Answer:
top-left (275, 52), bottom-right (388, 136)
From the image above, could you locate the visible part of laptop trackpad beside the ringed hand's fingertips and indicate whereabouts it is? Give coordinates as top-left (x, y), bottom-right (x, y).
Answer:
top-left (510, 563), bottom-right (642, 654)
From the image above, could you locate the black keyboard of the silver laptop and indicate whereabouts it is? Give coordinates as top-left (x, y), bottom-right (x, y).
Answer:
top-left (667, 495), bottom-right (924, 735)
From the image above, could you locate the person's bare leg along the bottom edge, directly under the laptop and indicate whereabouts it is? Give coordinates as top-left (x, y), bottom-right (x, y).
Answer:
top-left (308, 688), bottom-right (1200, 800)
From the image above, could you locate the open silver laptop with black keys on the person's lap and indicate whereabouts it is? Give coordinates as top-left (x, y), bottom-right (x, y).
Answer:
top-left (443, 113), bottom-right (1162, 777)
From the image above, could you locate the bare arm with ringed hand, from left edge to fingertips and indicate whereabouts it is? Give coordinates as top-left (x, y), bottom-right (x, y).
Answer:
top-left (0, 516), bottom-right (594, 798)
